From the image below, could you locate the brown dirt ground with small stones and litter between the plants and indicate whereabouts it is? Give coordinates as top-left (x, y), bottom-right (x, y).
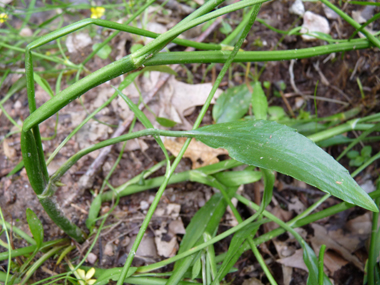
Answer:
top-left (0, 1), bottom-right (380, 284)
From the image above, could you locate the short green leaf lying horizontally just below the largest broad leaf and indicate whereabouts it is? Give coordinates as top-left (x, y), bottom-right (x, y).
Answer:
top-left (213, 170), bottom-right (262, 187)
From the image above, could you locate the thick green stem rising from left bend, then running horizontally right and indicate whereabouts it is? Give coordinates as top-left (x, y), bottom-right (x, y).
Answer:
top-left (24, 39), bottom-right (370, 130)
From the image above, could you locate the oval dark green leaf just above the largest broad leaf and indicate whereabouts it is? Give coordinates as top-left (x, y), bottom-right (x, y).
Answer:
top-left (212, 84), bottom-right (252, 123)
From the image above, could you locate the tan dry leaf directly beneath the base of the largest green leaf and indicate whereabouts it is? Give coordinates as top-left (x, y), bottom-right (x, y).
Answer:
top-left (164, 138), bottom-right (228, 169)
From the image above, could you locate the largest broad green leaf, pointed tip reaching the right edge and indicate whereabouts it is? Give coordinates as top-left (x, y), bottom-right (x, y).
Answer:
top-left (188, 121), bottom-right (378, 212)
